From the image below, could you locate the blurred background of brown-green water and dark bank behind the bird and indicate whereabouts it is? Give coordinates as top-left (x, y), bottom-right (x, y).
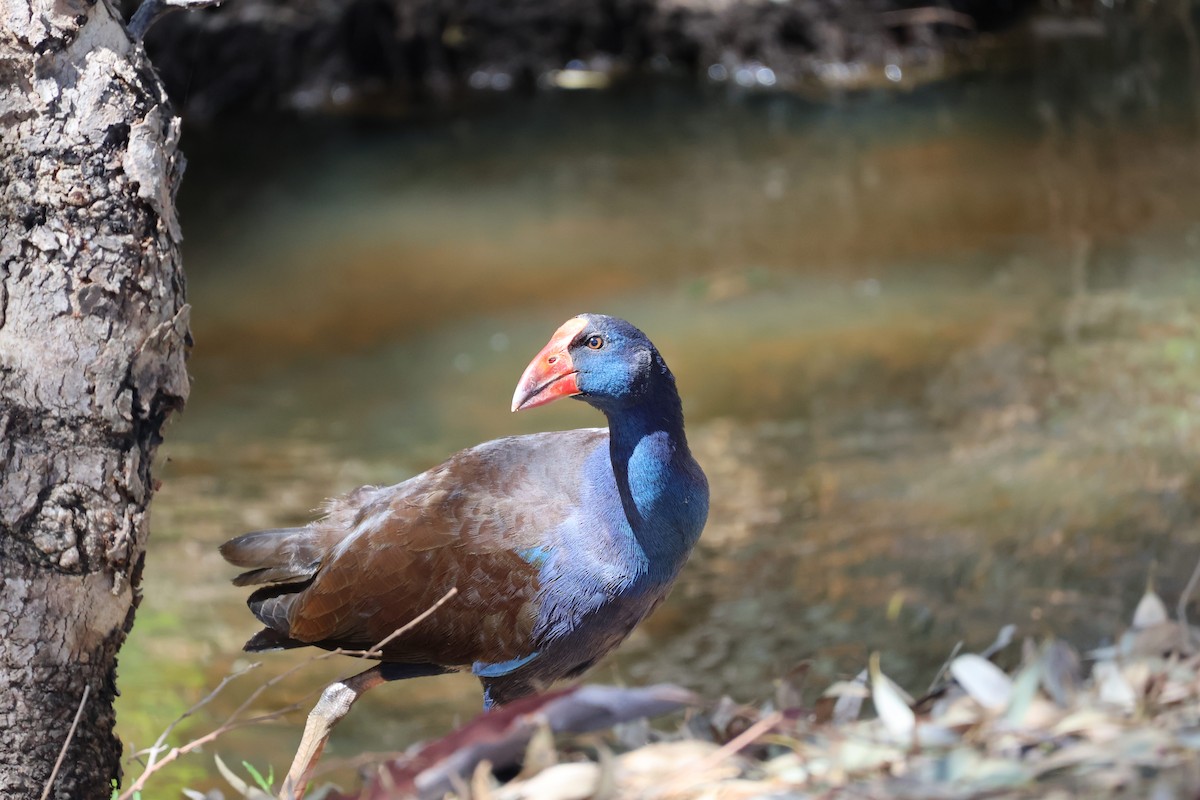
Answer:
top-left (118, 0), bottom-right (1200, 796)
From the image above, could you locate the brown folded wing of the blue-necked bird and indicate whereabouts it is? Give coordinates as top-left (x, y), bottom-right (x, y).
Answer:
top-left (278, 429), bottom-right (607, 666)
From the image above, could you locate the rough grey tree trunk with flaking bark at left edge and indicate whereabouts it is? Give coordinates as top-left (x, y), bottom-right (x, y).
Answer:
top-left (0, 0), bottom-right (191, 800)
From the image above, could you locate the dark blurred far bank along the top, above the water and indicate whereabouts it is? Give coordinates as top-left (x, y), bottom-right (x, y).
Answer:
top-left (131, 0), bottom-right (1046, 118)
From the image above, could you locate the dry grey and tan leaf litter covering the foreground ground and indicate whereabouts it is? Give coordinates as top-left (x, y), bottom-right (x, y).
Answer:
top-left (199, 567), bottom-right (1200, 800)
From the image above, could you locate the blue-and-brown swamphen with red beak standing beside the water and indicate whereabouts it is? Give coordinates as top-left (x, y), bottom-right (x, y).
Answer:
top-left (221, 314), bottom-right (709, 796)
